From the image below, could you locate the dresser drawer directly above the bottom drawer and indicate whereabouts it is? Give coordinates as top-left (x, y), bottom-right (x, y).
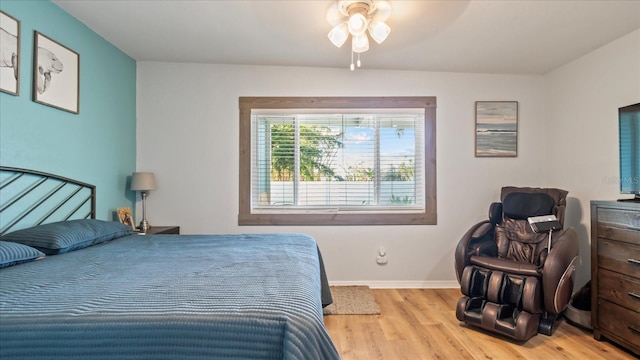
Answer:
top-left (598, 269), bottom-right (640, 311)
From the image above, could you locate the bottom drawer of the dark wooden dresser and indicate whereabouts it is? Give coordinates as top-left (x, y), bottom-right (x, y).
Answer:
top-left (598, 300), bottom-right (640, 351)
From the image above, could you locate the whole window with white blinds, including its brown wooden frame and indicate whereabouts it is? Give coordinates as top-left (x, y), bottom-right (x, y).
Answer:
top-left (238, 97), bottom-right (436, 225)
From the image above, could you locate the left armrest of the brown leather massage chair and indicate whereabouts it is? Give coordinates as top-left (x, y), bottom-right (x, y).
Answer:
top-left (454, 220), bottom-right (498, 283)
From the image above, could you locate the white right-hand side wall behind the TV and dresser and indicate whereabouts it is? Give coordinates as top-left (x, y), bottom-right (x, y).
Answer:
top-left (545, 30), bottom-right (640, 284)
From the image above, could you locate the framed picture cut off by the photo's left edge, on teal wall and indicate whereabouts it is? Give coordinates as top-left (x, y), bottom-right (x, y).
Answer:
top-left (0, 11), bottom-right (20, 96)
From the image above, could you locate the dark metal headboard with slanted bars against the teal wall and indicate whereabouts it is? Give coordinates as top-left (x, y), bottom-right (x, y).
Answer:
top-left (0, 166), bottom-right (96, 234)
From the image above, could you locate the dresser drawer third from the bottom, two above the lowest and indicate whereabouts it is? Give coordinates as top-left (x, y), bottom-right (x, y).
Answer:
top-left (598, 238), bottom-right (640, 277)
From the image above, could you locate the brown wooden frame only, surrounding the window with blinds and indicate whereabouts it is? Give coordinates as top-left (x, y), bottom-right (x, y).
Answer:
top-left (238, 96), bottom-right (437, 226)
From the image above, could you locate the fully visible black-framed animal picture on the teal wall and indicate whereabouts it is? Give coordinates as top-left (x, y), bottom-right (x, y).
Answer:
top-left (33, 31), bottom-right (80, 114)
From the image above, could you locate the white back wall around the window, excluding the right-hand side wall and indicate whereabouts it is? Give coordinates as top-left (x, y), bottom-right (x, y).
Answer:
top-left (137, 62), bottom-right (549, 286)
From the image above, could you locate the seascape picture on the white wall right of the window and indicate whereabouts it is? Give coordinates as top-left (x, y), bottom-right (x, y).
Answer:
top-left (476, 101), bottom-right (518, 157)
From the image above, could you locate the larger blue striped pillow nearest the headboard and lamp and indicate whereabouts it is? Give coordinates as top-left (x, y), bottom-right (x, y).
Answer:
top-left (0, 219), bottom-right (132, 255)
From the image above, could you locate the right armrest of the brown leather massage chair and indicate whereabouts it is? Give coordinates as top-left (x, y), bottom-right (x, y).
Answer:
top-left (542, 227), bottom-right (579, 314)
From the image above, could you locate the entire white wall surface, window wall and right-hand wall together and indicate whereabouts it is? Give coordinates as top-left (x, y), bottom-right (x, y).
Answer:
top-left (137, 31), bottom-right (640, 287)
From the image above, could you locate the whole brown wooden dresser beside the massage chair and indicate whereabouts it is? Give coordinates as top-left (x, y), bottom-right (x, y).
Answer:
top-left (591, 201), bottom-right (640, 355)
